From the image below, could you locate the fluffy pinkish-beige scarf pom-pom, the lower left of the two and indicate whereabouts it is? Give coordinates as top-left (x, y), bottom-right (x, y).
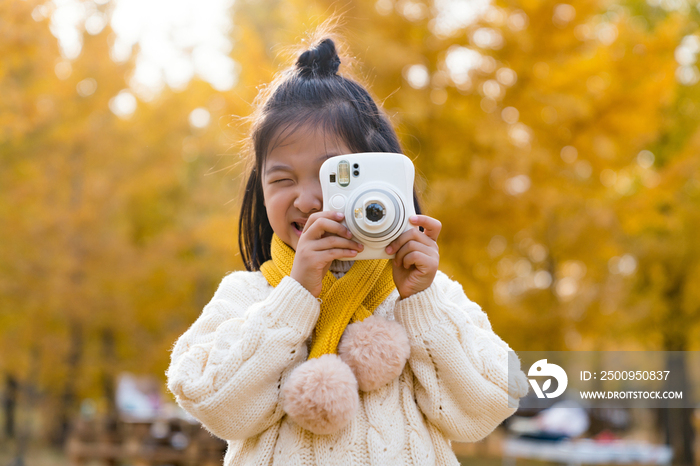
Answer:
top-left (282, 354), bottom-right (360, 435)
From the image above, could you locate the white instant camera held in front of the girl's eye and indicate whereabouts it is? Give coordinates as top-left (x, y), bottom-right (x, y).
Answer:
top-left (319, 152), bottom-right (416, 260)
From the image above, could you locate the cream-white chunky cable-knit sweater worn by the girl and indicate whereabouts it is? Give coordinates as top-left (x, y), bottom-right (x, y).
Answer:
top-left (167, 266), bottom-right (528, 466)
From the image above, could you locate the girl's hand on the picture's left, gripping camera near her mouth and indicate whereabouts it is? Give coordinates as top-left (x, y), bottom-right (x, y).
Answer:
top-left (290, 211), bottom-right (364, 298)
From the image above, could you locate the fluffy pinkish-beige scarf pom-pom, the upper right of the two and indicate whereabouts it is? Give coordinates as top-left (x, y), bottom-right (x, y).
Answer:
top-left (338, 316), bottom-right (411, 392)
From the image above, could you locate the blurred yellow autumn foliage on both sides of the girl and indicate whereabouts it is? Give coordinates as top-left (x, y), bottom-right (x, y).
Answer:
top-left (0, 0), bottom-right (700, 412)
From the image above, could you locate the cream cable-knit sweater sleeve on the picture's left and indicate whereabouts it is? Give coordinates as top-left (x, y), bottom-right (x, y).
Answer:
top-left (167, 272), bottom-right (320, 440)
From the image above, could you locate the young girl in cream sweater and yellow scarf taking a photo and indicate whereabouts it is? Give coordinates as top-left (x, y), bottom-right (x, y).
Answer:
top-left (167, 32), bottom-right (527, 466)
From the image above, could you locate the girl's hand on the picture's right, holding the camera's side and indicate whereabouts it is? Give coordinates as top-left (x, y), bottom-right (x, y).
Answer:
top-left (384, 215), bottom-right (442, 299)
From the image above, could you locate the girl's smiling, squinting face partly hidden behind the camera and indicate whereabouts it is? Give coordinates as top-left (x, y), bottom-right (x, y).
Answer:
top-left (262, 127), bottom-right (352, 251)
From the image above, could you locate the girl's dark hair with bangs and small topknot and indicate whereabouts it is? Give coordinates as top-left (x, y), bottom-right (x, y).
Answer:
top-left (238, 38), bottom-right (421, 271)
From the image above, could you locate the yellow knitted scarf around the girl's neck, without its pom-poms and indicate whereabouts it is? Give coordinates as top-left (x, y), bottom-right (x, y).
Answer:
top-left (260, 234), bottom-right (395, 359)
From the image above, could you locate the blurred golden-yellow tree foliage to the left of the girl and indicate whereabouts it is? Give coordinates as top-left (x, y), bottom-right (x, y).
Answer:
top-left (0, 1), bottom-right (240, 440)
